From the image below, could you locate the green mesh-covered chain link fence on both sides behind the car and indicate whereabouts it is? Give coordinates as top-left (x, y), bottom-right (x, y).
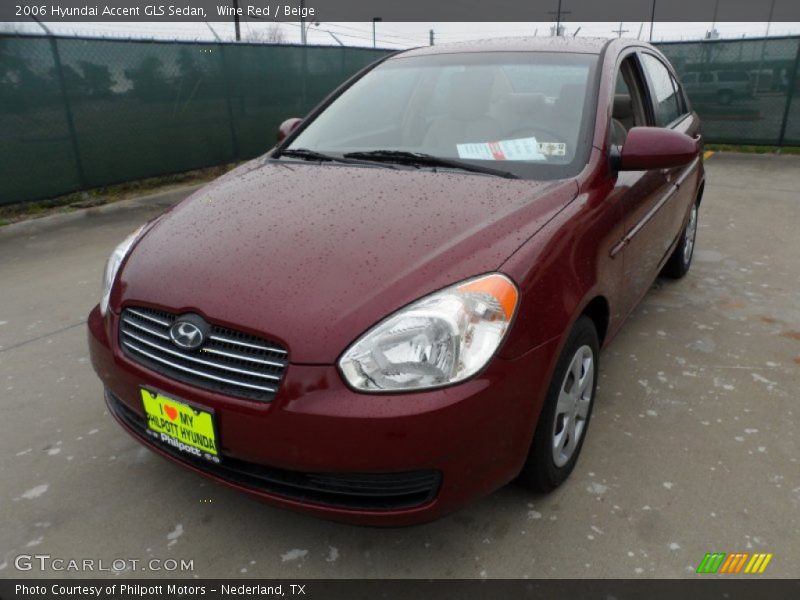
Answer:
top-left (0, 35), bottom-right (800, 204)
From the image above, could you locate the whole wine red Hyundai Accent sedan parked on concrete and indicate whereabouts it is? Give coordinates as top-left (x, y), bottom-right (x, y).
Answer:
top-left (88, 38), bottom-right (704, 525)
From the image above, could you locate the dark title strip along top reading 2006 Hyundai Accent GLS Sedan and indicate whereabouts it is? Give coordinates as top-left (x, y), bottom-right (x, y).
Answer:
top-left (0, 0), bottom-right (800, 22)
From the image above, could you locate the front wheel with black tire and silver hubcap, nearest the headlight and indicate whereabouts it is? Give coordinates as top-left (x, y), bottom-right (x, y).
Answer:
top-left (518, 316), bottom-right (600, 492)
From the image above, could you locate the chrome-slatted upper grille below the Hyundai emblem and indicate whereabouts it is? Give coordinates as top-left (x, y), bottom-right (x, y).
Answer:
top-left (119, 307), bottom-right (288, 402)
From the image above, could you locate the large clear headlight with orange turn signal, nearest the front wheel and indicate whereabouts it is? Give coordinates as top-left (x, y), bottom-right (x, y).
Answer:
top-left (339, 273), bottom-right (518, 392)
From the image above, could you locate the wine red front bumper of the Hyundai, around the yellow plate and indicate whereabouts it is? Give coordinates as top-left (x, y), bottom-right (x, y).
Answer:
top-left (88, 308), bottom-right (558, 526)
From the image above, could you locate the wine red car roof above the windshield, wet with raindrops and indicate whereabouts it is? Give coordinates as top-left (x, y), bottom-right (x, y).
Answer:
top-left (397, 36), bottom-right (618, 57)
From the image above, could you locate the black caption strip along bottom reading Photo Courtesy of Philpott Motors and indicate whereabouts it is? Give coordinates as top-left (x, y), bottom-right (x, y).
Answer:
top-left (0, 575), bottom-right (800, 600)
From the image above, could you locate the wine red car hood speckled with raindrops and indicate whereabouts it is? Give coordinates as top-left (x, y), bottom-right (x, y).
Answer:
top-left (117, 159), bottom-right (577, 364)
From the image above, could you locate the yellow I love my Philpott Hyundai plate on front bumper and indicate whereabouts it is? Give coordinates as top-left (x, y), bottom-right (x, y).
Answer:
top-left (141, 388), bottom-right (220, 463)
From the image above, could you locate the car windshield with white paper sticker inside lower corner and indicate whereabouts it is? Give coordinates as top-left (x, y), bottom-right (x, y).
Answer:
top-left (287, 52), bottom-right (597, 179)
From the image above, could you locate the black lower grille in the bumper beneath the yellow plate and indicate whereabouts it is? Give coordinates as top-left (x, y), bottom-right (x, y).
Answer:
top-left (106, 390), bottom-right (442, 511)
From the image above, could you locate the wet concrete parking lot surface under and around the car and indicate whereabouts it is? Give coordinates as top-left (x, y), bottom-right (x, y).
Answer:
top-left (0, 154), bottom-right (800, 578)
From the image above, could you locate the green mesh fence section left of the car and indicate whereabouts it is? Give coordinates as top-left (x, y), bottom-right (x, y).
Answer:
top-left (0, 36), bottom-right (384, 204)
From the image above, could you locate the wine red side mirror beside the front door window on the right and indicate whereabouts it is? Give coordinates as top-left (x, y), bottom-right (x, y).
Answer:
top-left (617, 127), bottom-right (699, 171)
